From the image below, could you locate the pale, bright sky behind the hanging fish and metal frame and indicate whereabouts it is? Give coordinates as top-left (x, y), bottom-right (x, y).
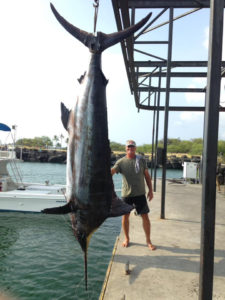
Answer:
top-left (0, 0), bottom-right (225, 145)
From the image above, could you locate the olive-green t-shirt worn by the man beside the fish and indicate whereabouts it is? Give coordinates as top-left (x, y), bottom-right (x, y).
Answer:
top-left (113, 156), bottom-right (147, 197)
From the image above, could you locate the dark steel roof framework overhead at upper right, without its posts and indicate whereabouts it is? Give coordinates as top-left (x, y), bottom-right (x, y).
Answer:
top-left (112, 0), bottom-right (225, 111)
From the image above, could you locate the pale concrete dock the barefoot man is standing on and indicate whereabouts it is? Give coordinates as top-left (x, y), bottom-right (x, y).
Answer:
top-left (99, 182), bottom-right (225, 300)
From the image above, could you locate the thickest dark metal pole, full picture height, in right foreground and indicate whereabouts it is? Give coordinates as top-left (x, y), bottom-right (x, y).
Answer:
top-left (199, 0), bottom-right (224, 300)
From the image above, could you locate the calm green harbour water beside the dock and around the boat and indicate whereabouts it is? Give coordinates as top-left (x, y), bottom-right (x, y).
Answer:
top-left (0, 163), bottom-right (182, 300)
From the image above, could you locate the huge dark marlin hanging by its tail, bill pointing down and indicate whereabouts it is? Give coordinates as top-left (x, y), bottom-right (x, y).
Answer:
top-left (43, 4), bottom-right (151, 289)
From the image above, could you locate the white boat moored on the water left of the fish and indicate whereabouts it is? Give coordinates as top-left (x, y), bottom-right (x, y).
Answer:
top-left (0, 124), bottom-right (66, 213)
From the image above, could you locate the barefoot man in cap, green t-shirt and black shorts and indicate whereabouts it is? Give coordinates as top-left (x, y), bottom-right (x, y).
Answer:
top-left (111, 140), bottom-right (156, 250)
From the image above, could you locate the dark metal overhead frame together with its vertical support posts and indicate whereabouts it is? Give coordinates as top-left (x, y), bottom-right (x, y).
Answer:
top-left (112, 0), bottom-right (225, 300)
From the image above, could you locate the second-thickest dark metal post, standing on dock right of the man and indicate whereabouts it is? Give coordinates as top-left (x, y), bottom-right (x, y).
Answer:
top-left (160, 7), bottom-right (173, 219)
